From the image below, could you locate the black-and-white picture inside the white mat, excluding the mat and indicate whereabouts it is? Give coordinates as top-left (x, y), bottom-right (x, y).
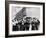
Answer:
top-left (11, 6), bottom-right (40, 31)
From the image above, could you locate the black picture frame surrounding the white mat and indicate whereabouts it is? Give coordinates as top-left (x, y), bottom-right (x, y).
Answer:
top-left (5, 1), bottom-right (45, 37)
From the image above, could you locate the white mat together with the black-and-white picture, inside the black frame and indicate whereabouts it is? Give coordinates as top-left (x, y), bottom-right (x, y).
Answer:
top-left (5, 3), bottom-right (43, 35)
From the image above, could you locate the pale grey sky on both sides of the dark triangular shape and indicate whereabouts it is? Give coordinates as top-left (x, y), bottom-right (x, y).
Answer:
top-left (12, 6), bottom-right (40, 19)
